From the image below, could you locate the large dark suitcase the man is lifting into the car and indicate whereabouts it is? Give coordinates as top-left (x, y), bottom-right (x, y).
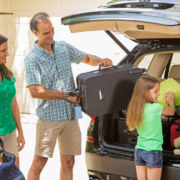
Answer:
top-left (73, 64), bottom-right (146, 116)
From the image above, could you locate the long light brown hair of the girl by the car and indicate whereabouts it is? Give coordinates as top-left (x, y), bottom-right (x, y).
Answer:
top-left (126, 75), bottom-right (159, 130)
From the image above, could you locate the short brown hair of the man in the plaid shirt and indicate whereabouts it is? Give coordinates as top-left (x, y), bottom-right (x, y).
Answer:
top-left (30, 12), bottom-right (50, 32)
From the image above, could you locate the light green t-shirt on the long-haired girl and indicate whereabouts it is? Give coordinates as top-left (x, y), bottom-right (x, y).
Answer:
top-left (136, 103), bottom-right (163, 151)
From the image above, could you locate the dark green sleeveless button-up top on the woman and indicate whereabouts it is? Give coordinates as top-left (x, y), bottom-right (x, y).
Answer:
top-left (0, 65), bottom-right (16, 135)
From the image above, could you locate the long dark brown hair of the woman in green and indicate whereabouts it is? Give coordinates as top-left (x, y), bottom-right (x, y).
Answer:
top-left (0, 34), bottom-right (13, 80)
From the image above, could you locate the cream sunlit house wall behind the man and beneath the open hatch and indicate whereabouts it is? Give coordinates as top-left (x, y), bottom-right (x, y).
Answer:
top-left (0, 0), bottom-right (135, 114)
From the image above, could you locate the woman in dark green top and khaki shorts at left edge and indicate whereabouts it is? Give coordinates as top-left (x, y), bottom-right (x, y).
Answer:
top-left (0, 35), bottom-right (25, 167)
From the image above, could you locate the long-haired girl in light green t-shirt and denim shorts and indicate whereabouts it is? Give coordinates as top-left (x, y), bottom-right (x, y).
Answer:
top-left (127, 75), bottom-right (175, 180)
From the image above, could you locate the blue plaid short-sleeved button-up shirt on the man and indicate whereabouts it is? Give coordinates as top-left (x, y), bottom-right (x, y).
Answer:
top-left (24, 41), bottom-right (85, 121)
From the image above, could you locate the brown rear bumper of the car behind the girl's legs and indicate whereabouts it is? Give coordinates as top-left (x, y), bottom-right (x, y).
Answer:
top-left (85, 153), bottom-right (180, 180)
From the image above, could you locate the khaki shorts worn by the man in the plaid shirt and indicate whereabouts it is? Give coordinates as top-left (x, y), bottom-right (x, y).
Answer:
top-left (35, 118), bottom-right (81, 158)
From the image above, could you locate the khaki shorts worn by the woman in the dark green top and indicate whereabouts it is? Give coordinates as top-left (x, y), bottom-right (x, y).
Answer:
top-left (0, 130), bottom-right (19, 157)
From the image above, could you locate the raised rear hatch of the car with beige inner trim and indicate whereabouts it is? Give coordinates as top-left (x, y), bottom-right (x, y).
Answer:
top-left (61, 8), bottom-right (180, 44)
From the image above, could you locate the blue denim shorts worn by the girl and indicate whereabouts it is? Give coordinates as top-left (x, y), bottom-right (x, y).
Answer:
top-left (134, 149), bottom-right (163, 168)
